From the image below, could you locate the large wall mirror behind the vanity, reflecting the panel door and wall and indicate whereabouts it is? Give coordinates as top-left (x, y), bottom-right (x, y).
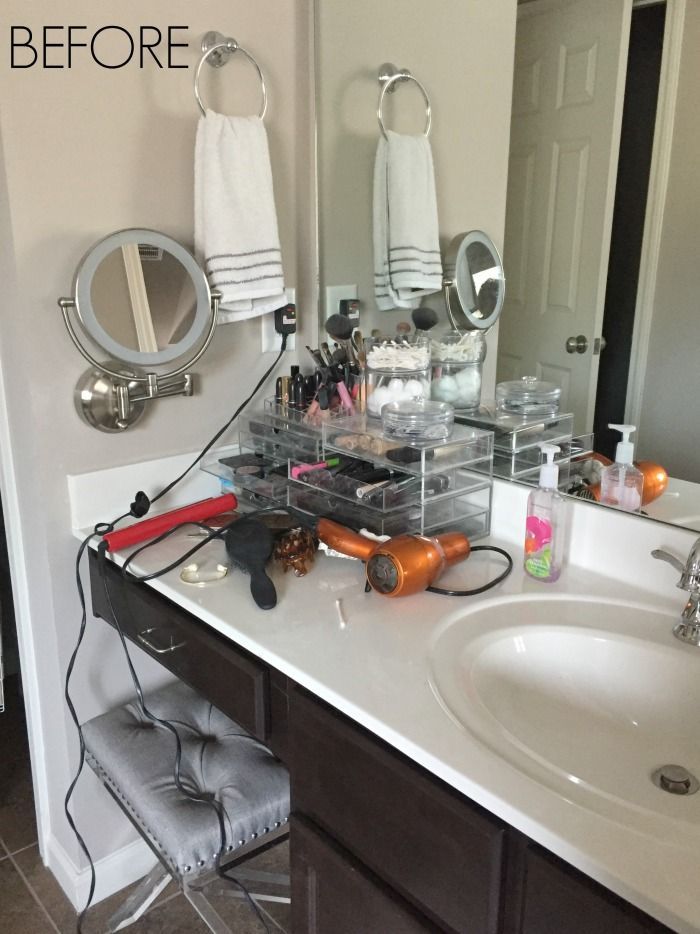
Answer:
top-left (315, 0), bottom-right (700, 529)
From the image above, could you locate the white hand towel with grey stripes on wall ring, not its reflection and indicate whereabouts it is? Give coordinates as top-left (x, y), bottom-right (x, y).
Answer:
top-left (194, 110), bottom-right (287, 324)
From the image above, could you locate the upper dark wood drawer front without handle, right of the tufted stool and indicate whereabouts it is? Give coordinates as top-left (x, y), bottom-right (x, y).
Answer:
top-left (290, 687), bottom-right (506, 934)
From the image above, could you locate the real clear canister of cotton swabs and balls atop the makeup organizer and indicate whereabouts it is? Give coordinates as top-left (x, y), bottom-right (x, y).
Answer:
top-left (364, 336), bottom-right (430, 418)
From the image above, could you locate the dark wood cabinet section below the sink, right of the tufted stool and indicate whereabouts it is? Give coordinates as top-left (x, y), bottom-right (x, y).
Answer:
top-left (289, 687), bottom-right (669, 934)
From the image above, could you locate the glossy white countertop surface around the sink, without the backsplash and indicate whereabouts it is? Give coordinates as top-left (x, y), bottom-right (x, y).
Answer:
top-left (87, 533), bottom-right (700, 932)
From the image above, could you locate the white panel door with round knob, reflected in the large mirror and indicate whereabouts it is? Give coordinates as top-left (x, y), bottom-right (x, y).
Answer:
top-left (497, 0), bottom-right (632, 432)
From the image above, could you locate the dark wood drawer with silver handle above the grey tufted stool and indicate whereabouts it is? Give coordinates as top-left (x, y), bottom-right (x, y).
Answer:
top-left (90, 554), bottom-right (270, 743)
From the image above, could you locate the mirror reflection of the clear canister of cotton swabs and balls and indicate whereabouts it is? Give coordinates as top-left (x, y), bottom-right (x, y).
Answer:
top-left (430, 331), bottom-right (486, 409)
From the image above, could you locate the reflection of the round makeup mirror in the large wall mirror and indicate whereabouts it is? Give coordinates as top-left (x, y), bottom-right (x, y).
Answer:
top-left (443, 230), bottom-right (506, 331)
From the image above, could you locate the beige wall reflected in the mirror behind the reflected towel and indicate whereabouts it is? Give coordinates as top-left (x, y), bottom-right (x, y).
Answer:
top-left (317, 0), bottom-right (516, 393)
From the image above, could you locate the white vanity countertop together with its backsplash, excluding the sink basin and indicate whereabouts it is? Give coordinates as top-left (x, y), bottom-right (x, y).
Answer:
top-left (69, 455), bottom-right (700, 934)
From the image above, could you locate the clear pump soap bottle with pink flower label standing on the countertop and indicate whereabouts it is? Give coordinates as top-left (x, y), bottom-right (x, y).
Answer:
top-left (524, 444), bottom-right (566, 583)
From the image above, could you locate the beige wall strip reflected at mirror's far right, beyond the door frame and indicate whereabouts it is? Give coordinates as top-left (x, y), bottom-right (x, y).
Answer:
top-left (639, 0), bottom-right (700, 481)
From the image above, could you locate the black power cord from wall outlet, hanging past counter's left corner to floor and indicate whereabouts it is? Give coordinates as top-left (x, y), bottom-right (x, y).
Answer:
top-left (63, 325), bottom-right (293, 934)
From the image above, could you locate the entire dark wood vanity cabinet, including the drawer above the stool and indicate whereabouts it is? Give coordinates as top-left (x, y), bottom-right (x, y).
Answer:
top-left (90, 554), bottom-right (669, 934)
